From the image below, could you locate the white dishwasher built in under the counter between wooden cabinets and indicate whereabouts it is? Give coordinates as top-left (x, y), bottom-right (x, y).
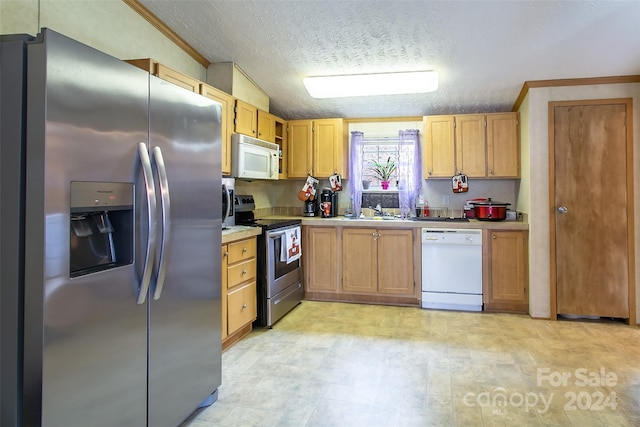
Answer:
top-left (422, 228), bottom-right (482, 311)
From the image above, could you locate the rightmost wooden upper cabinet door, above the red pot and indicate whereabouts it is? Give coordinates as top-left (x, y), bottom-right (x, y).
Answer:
top-left (487, 113), bottom-right (520, 178)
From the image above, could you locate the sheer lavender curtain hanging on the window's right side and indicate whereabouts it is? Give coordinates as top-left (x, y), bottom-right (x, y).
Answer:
top-left (398, 129), bottom-right (422, 218)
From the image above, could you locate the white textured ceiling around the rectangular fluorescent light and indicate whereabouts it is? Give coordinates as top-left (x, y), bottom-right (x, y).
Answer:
top-left (141, 0), bottom-right (640, 119)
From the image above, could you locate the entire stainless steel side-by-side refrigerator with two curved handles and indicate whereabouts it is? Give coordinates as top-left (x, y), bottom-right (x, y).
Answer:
top-left (0, 29), bottom-right (222, 427)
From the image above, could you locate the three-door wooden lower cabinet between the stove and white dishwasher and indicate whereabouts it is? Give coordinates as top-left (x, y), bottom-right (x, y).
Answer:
top-left (303, 227), bottom-right (421, 306)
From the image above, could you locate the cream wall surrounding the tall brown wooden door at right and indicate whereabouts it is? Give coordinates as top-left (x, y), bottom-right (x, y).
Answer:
top-left (518, 83), bottom-right (640, 321)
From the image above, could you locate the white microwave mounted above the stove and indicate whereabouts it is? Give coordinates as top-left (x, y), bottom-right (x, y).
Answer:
top-left (231, 133), bottom-right (279, 179)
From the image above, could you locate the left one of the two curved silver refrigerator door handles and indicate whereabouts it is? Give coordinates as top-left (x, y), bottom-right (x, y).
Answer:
top-left (137, 142), bottom-right (157, 304)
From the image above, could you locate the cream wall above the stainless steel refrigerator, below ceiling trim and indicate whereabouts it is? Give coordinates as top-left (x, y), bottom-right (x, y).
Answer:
top-left (0, 0), bottom-right (206, 81)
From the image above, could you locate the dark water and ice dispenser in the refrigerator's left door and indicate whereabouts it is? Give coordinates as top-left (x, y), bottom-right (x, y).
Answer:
top-left (69, 181), bottom-right (134, 277)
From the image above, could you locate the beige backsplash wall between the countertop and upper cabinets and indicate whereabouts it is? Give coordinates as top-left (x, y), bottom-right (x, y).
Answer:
top-left (235, 179), bottom-right (520, 216)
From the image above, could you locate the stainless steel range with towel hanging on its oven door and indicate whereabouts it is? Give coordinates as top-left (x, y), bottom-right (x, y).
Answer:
top-left (234, 195), bottom-right (304, 327)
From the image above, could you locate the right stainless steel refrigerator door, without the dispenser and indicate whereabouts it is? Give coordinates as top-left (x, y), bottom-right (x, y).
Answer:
top-left (148, 76), bottom-right (222, 427)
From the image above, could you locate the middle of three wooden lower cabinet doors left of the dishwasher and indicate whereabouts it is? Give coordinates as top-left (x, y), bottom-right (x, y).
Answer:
top-left (342, 228), bottom-right (378, 293)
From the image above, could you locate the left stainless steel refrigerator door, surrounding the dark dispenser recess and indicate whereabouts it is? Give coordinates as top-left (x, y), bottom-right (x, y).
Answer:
top-left (24, 30), bottom-right (148, 427)
